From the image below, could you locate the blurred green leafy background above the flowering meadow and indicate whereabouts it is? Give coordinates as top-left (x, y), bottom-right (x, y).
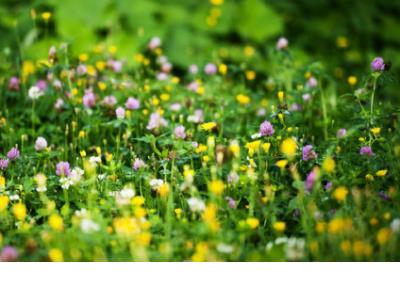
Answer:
top-left (0, 0), bottom-right (400, 87)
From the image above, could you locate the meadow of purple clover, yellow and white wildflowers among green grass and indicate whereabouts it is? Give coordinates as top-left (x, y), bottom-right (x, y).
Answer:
top-left (0, 1), bottom-right (400, 262)
